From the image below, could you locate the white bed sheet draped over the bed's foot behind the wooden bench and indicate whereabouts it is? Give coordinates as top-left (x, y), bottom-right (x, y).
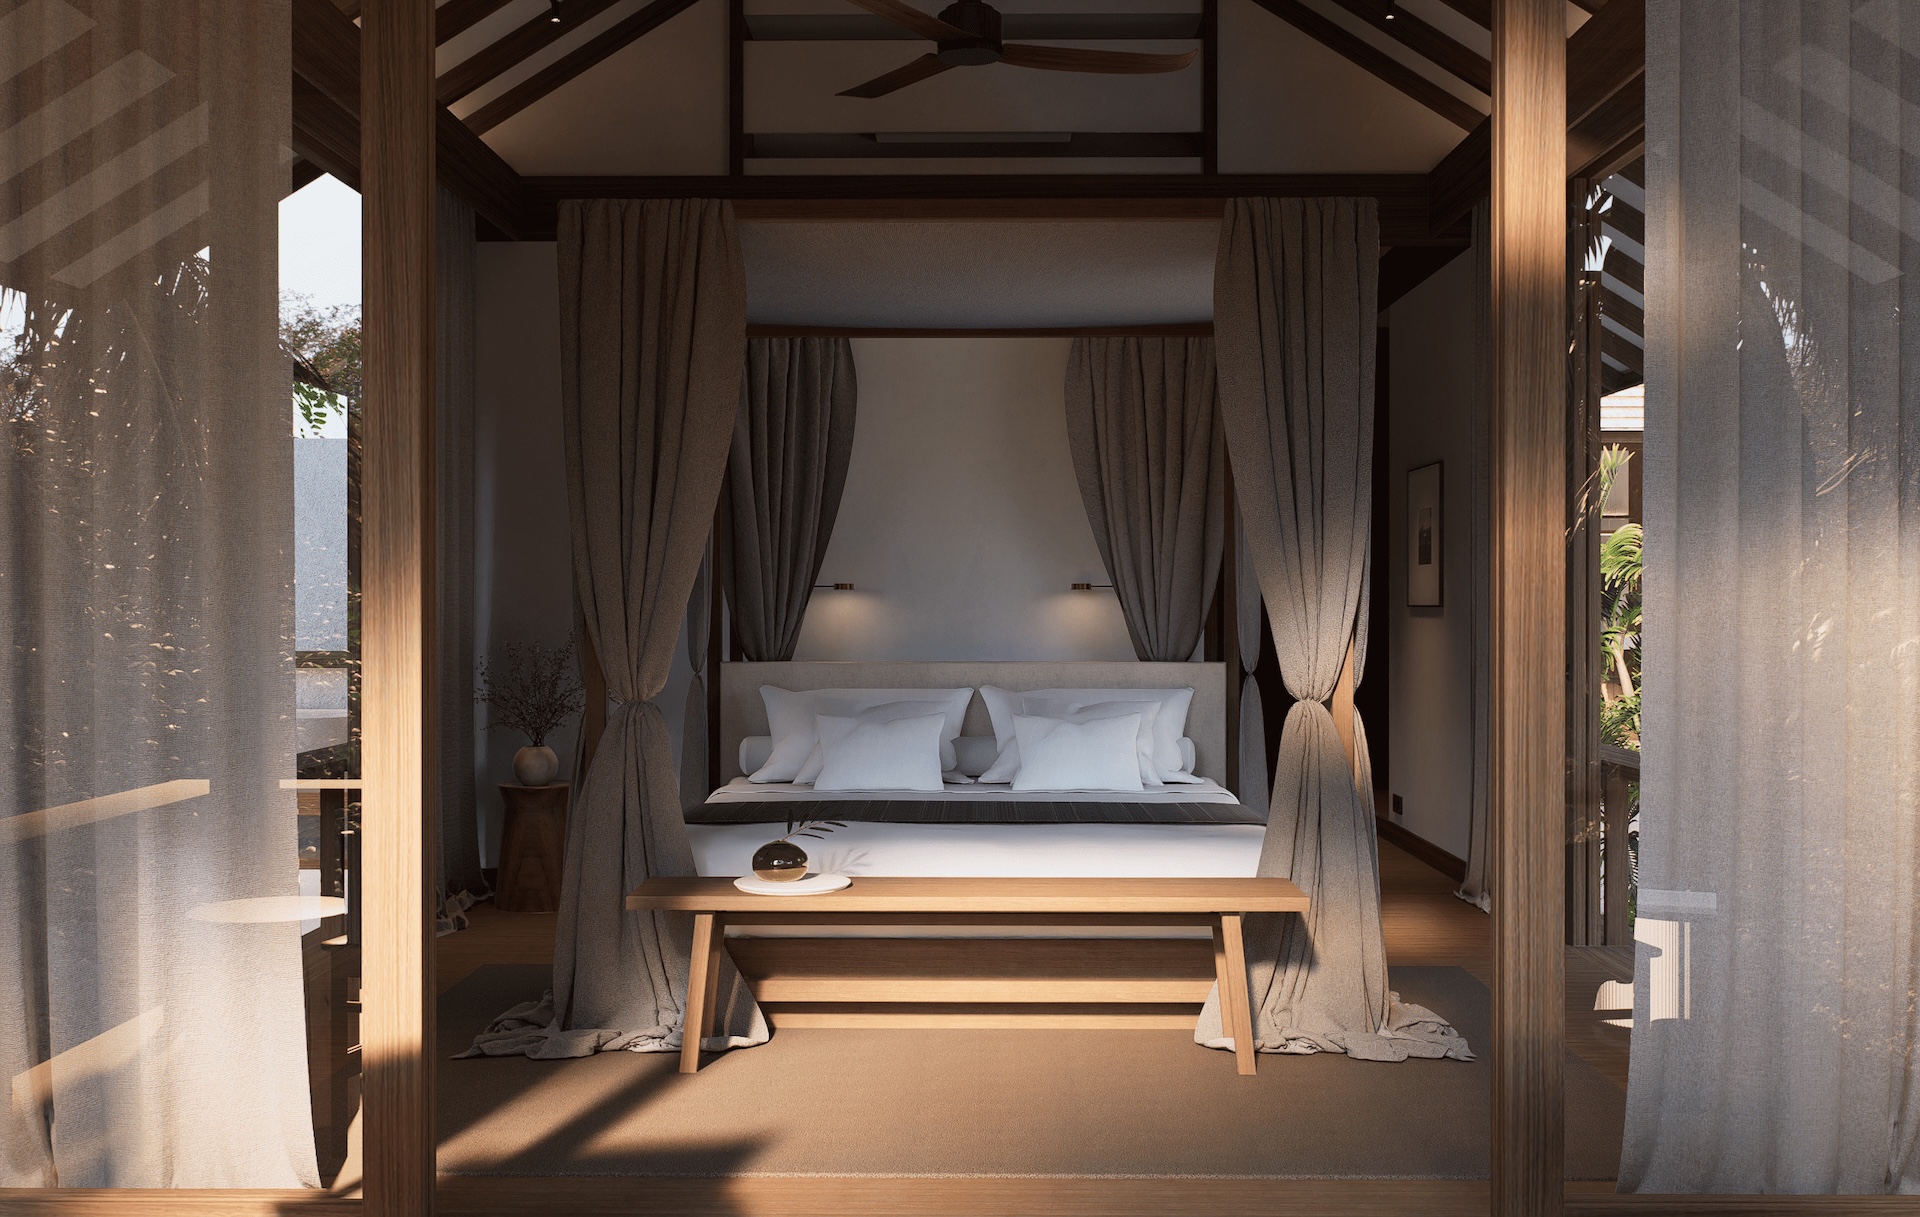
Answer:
top-left (687, 813), bottom-right (1267, 939)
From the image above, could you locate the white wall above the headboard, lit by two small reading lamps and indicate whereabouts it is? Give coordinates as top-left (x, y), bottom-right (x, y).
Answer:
top-left (795, 338), bottom-right (1133, 660)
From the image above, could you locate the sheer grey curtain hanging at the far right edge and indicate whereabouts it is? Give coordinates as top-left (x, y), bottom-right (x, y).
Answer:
top-left (1620, 0), bottom-right (1920, 1192)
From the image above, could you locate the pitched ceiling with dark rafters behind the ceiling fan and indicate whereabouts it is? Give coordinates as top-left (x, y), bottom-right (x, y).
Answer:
top-left (412, 0), bottom-right (1603, 175)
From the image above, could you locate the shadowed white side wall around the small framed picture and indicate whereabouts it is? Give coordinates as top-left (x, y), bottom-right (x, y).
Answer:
top-left (1386, 251), bottom-right (1473, 858)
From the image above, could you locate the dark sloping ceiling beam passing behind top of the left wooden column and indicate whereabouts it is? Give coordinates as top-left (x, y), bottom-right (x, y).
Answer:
top-left (292, 0), bottom-right (524, 236)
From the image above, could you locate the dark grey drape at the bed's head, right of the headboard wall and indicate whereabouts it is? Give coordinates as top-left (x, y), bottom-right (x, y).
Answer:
top-left (1068, 338), bottom-right (1227, 662)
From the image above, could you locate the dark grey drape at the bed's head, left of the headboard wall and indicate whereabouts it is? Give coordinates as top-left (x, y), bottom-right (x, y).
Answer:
top-left (726, 338), bottom-right (856, 662)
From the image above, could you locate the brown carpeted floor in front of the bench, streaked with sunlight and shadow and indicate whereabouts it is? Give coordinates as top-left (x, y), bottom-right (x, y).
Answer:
top-left (438, 966), bottom-right (1624, 1179)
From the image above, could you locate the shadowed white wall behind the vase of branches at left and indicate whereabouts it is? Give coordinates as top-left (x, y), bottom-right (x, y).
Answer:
top-left (474, 242), bottom-right (689, 866)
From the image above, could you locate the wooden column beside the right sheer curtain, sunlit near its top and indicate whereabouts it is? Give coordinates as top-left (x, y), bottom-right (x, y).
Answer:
top-left (1490, 0), bottom-right (1567, 1217)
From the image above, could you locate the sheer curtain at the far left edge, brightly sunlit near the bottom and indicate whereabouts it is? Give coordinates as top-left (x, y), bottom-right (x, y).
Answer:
top-left (0, 0), bottom-right (317, 1188)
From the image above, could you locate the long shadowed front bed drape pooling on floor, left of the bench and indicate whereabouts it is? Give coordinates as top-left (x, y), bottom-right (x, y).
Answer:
top-left (472, 200), bottom-right (768, 1058)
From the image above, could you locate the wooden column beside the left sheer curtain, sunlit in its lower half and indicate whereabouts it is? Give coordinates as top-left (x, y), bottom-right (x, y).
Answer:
top-left (361, 0), bottom-right (436, 1217)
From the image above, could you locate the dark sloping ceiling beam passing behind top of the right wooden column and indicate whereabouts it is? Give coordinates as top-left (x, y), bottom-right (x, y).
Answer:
top-left (1427, 0), bottom-right (1647, 230)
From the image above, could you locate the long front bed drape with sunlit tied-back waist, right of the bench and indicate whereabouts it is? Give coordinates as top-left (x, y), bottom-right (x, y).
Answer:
top-left (1194, 198), bottom-right (1471, 1060)
